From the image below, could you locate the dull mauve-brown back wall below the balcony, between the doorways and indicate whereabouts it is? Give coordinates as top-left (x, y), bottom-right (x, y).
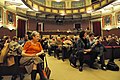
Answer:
top-left (28, 19), bottom-right (90, 31)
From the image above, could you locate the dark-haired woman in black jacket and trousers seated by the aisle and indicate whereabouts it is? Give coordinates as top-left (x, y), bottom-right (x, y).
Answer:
top-left (77, 31), bottom-right (97, 71)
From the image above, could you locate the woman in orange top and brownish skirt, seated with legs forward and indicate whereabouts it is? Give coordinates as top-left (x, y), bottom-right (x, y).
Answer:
top-left (20, 31), bottom-right (48, 80)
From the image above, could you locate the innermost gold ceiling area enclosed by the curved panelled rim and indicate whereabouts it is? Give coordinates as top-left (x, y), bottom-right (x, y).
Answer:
top-left (33, 0), bottom-right (86, 9)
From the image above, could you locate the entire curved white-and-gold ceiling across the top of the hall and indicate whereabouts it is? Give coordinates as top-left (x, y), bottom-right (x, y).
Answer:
top-left (0, 0), bottom-right (120, 21)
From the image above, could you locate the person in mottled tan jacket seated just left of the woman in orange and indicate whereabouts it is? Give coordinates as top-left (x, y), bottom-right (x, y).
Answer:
top-left (6, 36), bottom-right (22, 66)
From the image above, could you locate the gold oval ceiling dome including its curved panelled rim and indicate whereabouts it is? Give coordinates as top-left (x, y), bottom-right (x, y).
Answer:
top-left (22, 0), bottom-right (115, 15)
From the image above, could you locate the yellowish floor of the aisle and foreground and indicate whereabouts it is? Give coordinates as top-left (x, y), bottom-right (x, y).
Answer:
top-left (3, 55), bottom-right (120, 80)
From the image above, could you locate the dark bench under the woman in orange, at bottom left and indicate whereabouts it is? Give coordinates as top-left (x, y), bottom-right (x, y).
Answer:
top-left (0, 56), bottom-right (27, 80)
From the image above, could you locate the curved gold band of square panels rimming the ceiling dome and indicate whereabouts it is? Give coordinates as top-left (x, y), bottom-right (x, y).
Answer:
top-left (22, 0), bottom-right (116, 15)
